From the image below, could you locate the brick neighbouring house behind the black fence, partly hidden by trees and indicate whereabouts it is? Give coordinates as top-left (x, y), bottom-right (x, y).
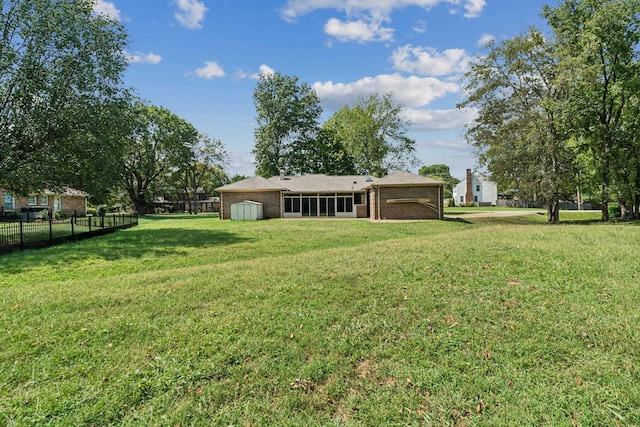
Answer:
top-left (0, 188), bottom-right (89, 220)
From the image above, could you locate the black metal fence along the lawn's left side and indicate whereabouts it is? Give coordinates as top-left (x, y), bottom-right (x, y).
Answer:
top-left (0, 214), bottom-right (138, 253)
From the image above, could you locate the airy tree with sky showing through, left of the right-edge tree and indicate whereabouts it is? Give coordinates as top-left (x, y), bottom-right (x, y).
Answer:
top-left (459, 28), bottom-right (576, 223)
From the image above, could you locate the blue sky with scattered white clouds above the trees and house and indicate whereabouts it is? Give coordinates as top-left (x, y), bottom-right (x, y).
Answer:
top-left (95, 0), bottom-right (556, 179)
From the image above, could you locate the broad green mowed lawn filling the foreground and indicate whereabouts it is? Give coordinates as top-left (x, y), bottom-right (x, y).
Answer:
top-left (0, 212), bottom-right (640, 426)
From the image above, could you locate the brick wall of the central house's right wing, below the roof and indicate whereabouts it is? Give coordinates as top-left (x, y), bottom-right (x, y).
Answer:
top-left (370, 186), bottom-right (444, 219)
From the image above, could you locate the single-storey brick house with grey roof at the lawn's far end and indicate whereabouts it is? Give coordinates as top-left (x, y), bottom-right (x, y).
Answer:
top-left (216, 172), bottom-right (444, 219)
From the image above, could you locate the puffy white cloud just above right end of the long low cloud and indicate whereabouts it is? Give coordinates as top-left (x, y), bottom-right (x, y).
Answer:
top-left (391, 45), bottom-right (470, 76)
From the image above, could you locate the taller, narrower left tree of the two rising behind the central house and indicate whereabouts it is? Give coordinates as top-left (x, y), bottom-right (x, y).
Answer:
top-left (253, 73), bottom-right (322, 177)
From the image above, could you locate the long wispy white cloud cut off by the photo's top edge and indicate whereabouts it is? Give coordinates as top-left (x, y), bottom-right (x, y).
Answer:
top-left (281, 0), bottom-right (486, 21)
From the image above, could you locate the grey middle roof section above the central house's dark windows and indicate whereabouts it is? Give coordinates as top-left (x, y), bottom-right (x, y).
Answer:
top-left (269, 174), bottom-right (376, 193)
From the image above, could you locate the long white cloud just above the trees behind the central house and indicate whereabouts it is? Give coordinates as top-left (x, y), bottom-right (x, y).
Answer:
top-left (312, 74), bottom-right (460, 109)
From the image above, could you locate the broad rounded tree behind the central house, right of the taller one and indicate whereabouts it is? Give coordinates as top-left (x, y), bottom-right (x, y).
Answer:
top-left (324, 93), bottom-right (417, 176)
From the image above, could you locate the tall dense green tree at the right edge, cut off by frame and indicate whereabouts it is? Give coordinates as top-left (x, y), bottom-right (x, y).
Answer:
top-left (543, 0), bottom-right (640, 221)
